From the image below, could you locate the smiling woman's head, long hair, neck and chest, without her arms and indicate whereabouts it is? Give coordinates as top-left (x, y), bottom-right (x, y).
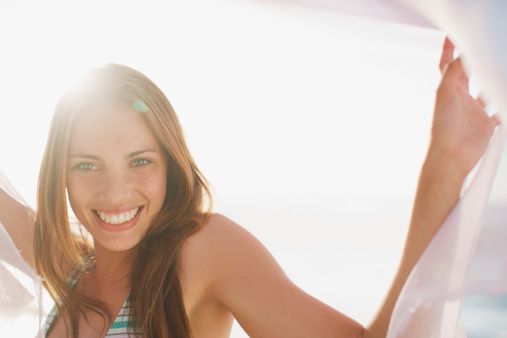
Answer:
top-left (31, 64), bottom-right (211, 337)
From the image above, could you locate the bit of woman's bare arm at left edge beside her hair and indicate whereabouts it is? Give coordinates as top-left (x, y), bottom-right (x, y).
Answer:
top-left (0, 188), bottom-right (35, 269)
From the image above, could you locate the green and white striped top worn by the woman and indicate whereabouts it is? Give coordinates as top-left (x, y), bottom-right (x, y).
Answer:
top-left (44, 257), bottom-right (141, 338)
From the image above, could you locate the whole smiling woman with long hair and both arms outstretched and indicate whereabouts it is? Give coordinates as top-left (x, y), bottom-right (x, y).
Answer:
top-left (0, 40), bottom-right (498, 338)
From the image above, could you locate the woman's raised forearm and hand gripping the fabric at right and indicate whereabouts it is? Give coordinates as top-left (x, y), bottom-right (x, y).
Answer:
top-left (365, 39), bottom-right (499, 338)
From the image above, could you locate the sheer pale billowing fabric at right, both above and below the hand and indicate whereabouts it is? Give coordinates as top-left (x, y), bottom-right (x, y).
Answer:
top-left (380, 0), bottom-right (507, 338)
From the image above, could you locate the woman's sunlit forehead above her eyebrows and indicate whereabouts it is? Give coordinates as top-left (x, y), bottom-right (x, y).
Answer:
top-left (69, 103), bottom-right (158, 152)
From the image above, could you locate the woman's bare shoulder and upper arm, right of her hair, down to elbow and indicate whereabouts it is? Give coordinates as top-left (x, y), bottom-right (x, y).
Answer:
top-left (194, 215), bottom-right (363, 338)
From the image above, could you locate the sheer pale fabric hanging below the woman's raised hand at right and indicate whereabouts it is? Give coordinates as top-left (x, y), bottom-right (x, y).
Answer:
top-left (388, 126), bottom-right (507, 338)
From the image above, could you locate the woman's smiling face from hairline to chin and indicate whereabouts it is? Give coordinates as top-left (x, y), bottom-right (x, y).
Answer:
top-left (67, 103), bottom-right (167, 251)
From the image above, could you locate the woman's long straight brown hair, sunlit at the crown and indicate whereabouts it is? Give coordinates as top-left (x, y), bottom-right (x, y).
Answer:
top-left (34, 64), bottom-right (212, 338)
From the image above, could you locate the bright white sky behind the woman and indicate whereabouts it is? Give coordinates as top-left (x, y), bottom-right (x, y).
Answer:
top-left (0, 0), bottom-right (504, 337)
